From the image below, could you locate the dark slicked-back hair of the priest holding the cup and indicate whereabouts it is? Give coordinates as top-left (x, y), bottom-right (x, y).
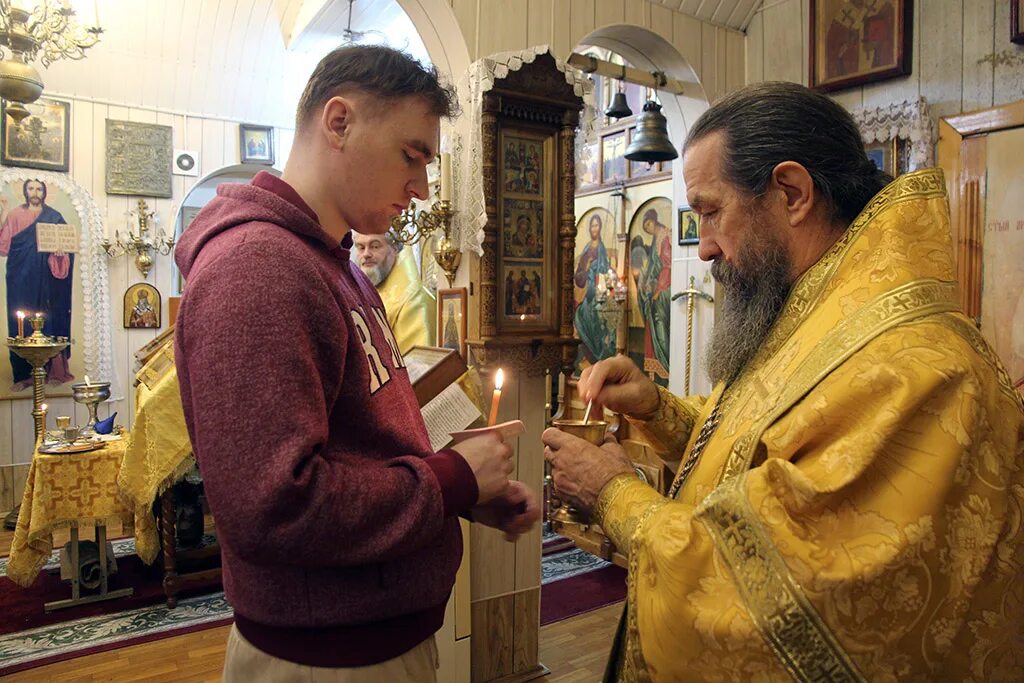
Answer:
top-left (684, 82), bottom-right (892, 224)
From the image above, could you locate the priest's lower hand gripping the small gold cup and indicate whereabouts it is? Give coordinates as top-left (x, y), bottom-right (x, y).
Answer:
top-left (541, 428), bottom-right (634, 513)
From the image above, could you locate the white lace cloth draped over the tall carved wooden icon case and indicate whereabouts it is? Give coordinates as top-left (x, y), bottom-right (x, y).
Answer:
top-left (447, 45), bottom-right (594, 254)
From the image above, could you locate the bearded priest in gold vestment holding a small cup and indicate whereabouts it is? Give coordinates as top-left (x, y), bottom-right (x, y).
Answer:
top-left (543, 83), bottom-right (1024, 682)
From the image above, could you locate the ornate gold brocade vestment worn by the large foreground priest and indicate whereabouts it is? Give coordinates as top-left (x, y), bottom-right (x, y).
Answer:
top-left (596, 170), bottom-right (1024, 681)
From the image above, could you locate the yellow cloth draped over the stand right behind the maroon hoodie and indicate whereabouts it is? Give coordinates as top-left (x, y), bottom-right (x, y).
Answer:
top-left (117, 339), bottom-right (196, 564)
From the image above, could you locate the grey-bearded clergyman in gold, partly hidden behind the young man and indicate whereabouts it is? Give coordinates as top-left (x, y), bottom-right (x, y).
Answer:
top-left (352, 232), bottom-right (437, 355)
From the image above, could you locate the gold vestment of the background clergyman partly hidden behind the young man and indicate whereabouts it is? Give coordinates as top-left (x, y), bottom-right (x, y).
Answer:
top-left (377, 247), bottom-right (437, 355)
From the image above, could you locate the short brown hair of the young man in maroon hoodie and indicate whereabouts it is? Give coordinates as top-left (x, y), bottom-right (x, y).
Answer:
top-left (295, 45), bottom-right (458, 129)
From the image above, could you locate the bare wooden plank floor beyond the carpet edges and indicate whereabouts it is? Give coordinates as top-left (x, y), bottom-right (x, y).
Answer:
top-left (4, 603), bottom-right (623, 683)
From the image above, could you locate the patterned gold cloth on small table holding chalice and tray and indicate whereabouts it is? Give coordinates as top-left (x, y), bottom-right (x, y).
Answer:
top-left (7, 440), bottom-right (137, 587)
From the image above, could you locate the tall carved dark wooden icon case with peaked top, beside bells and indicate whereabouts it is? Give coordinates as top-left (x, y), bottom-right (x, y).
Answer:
top-left (467, 54), bottom-right (583, 376)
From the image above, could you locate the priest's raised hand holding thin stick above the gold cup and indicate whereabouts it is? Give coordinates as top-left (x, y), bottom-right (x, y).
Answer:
top-left (577, 355), bottom-right (660, 418)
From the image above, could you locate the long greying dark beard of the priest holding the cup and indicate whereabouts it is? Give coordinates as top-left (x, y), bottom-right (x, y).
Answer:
top-left (707, 222), bottom-right (793, 384)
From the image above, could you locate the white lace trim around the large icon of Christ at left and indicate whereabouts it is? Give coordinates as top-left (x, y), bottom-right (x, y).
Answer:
top-left (0, 168), bottom-right (120, 396)
